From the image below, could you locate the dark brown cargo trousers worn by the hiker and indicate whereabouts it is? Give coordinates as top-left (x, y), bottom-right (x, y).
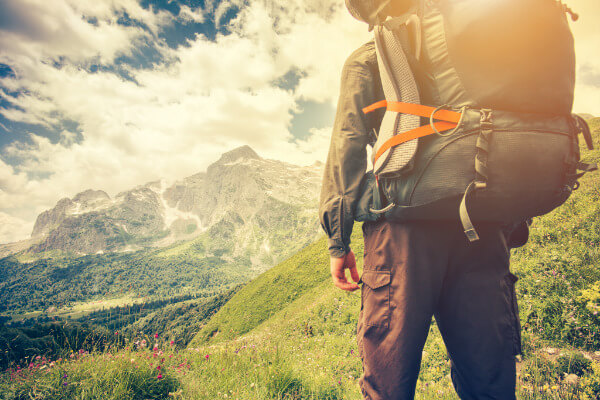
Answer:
top-left (357, 220), bottom-right (521, 400)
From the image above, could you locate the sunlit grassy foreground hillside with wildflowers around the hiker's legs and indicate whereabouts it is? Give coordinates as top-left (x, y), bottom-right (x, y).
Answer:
top-left (0, 118), bottom-right (600, 400)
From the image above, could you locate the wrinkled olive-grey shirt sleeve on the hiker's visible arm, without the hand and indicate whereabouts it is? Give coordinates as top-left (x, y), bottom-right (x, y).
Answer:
top-left (319, 50), bottom-right (375, 257)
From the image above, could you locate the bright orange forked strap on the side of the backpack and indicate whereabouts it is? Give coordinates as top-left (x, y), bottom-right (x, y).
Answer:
top-left (362, 100), bottom-right (462, 162)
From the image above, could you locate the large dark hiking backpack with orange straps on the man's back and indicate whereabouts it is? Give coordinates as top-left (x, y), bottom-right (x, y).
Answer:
top-left (347, 0), bottom-right (596, 241)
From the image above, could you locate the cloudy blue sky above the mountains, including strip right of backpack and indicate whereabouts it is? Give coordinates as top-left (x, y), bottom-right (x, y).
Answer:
top-left (0, 0), bottom-right (600, 243)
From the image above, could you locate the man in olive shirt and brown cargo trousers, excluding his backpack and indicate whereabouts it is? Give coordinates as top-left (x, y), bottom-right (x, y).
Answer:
top-left (319, 3), bottom-right (528, 400)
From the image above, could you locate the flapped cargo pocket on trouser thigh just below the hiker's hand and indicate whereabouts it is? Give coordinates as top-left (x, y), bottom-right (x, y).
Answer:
top-left (361, 270), bottom-right (391, 328)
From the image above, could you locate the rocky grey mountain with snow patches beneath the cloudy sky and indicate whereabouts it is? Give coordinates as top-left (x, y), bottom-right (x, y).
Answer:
top-left (0, 146), bottom-right (321, 265)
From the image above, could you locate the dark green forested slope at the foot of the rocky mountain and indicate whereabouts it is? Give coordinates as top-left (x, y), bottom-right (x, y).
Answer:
top-left (0, 236), bottom-right (256, 317)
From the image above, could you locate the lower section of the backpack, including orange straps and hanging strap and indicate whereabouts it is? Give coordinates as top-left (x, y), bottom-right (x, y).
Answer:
top-left (362, 100), bottom-right (596, 241)
